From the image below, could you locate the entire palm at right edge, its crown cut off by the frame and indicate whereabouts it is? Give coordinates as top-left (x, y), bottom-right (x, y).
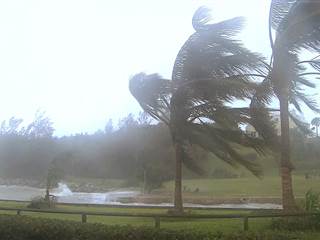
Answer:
top-left (254, 0), bottom-right (320, 211)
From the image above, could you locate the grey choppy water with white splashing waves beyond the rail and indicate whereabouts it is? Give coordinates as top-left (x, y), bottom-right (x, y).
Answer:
top-left (0, 183), bottom-right (281, 209)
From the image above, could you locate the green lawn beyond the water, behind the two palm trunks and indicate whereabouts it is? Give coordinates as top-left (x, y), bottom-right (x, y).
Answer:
top-left (160, 176), bottom-right (320, 198)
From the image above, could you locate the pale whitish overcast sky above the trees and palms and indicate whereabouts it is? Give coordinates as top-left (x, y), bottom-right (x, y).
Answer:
top-left (0, 0), bottom-right (318, 135)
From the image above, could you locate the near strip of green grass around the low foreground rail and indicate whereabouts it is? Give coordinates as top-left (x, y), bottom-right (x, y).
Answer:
top-left (0, 201), bottom-right (320, 237)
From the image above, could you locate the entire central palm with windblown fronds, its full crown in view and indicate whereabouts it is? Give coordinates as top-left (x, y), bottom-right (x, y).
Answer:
top-left (129, 8), bottom-right (272, 213)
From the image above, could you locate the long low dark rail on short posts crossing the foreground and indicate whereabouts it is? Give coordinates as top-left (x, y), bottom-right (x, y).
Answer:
top-left (0, 208), bottom-right (320, 231)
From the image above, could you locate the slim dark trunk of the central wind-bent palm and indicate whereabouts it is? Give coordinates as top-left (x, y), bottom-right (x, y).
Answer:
top-left (174, 143), bottom-right (183, 213)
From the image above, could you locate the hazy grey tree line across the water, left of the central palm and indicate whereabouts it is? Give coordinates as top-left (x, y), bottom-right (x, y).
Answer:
top-left (0, 112), bottom-right (178, 189)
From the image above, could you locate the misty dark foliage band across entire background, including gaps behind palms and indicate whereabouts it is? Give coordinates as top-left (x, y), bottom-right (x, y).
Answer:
top-left (0, 111), bottom-right (320, 189)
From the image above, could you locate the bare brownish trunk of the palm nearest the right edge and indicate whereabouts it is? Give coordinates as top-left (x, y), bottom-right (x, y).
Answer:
top-left (279, 97), bottom-right (296, 211)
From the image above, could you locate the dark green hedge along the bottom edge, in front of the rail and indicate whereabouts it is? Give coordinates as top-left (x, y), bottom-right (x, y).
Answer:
top-left (0, 215), bottom-right (297, 240)
